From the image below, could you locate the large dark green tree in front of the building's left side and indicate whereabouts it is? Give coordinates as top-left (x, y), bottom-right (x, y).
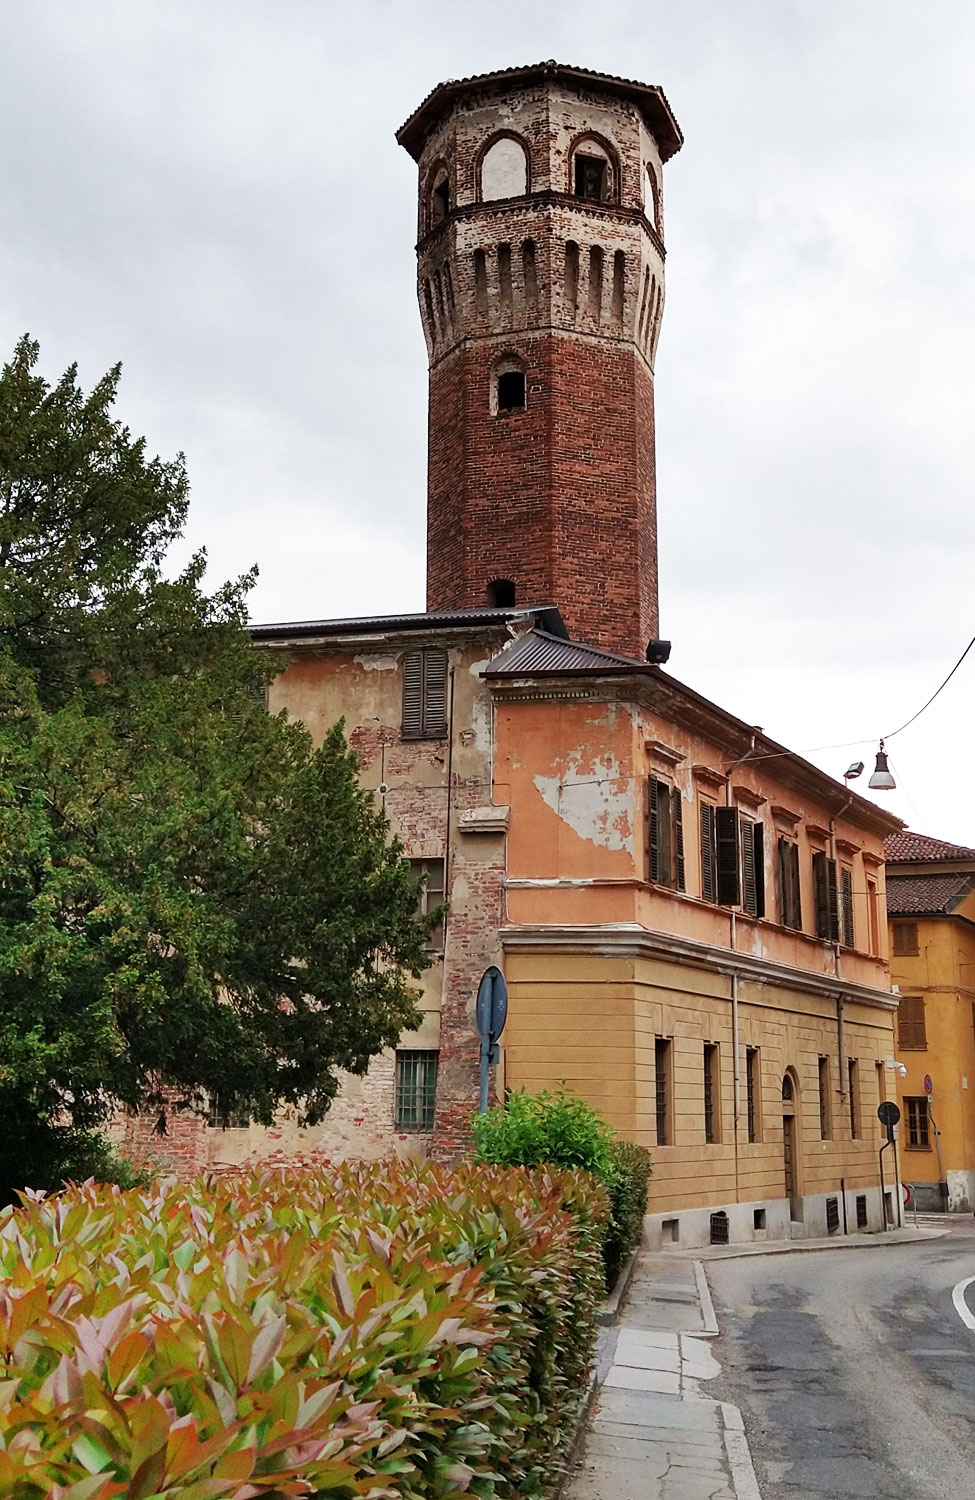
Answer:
top-left (0, 339), bottom-right (431, 1190)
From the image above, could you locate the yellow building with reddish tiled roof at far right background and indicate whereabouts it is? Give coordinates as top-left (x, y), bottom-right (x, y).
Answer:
top-left (885, 833), bottom-right (975, 1212)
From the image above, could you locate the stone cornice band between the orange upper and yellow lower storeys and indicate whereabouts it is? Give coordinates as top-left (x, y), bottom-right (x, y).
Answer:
top-left (501, 923), bottom-right (900, 1011)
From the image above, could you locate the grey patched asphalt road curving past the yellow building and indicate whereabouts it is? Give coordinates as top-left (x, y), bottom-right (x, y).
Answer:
top-left (707, 1217), bottom-right (975, 1500)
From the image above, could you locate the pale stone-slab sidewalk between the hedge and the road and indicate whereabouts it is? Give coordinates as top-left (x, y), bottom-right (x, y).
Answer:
top-left (563, 1253), bottom-right (761, 1500)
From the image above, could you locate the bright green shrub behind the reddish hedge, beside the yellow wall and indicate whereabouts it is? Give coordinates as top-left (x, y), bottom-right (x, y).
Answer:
top-left (473, 1085), bottom-right (650, 1289)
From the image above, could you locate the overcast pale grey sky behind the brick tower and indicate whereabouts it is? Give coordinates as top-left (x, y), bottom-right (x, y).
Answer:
top-left (0, 0), bottom-right (975, 845)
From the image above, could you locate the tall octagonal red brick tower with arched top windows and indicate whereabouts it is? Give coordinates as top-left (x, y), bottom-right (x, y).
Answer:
top-left (398, 63), bottom-right (683, 656)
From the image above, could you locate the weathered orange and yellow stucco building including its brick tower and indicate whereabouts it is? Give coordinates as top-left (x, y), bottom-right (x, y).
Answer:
top-left (123, 63), bottom-right (902, 1245)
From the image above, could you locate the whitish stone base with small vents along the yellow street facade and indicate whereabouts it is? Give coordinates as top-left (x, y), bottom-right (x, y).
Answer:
top-left (644, 1187), bottom-right (896, 1250)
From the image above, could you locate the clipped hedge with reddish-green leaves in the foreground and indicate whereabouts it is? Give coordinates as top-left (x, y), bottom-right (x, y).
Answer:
top-left (0, 1163), bottom-right (608, 1500)
